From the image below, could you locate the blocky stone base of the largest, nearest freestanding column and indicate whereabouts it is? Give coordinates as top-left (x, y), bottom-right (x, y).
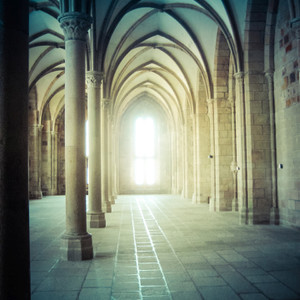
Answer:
top-left (61, 233), bottom-right (94, 261)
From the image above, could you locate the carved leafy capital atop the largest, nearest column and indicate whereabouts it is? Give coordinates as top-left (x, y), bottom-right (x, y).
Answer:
top-left (58, 12), bottom-right (92, 41)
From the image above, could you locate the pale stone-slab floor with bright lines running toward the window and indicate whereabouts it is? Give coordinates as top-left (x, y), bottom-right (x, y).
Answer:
top-left (30, 196), bottom-right (300, 300)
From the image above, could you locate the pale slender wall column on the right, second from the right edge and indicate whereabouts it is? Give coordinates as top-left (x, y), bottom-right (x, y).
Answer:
top-left (234, 72), bottom-right (253, 224)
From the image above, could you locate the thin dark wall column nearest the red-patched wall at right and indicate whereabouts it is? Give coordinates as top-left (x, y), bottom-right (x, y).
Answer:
top-left (265, 71), bottom-right (279, 225)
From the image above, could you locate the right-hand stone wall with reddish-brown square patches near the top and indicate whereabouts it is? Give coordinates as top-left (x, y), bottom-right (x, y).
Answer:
top-left (274, 1), bottom-right (300, 226)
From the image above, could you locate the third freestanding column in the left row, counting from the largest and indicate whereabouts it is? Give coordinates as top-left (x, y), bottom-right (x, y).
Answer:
top-left (101, 99), bottom-right (111, 213)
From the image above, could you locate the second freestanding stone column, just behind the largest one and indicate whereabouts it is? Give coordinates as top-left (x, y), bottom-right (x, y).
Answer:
top-left (86, 71), bottom-right (106, 228)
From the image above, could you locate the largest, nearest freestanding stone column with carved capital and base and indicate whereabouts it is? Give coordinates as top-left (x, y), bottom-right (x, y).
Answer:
top-left (59, 12), bottom-right (93, 260)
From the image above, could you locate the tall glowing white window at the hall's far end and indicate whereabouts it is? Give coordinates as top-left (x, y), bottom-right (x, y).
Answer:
top-left (135, 117), bottom-right (155, 185)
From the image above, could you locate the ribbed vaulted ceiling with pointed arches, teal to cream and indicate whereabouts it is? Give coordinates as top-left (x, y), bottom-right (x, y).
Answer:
top-left (29, 0), bottom-right (247, 124)
